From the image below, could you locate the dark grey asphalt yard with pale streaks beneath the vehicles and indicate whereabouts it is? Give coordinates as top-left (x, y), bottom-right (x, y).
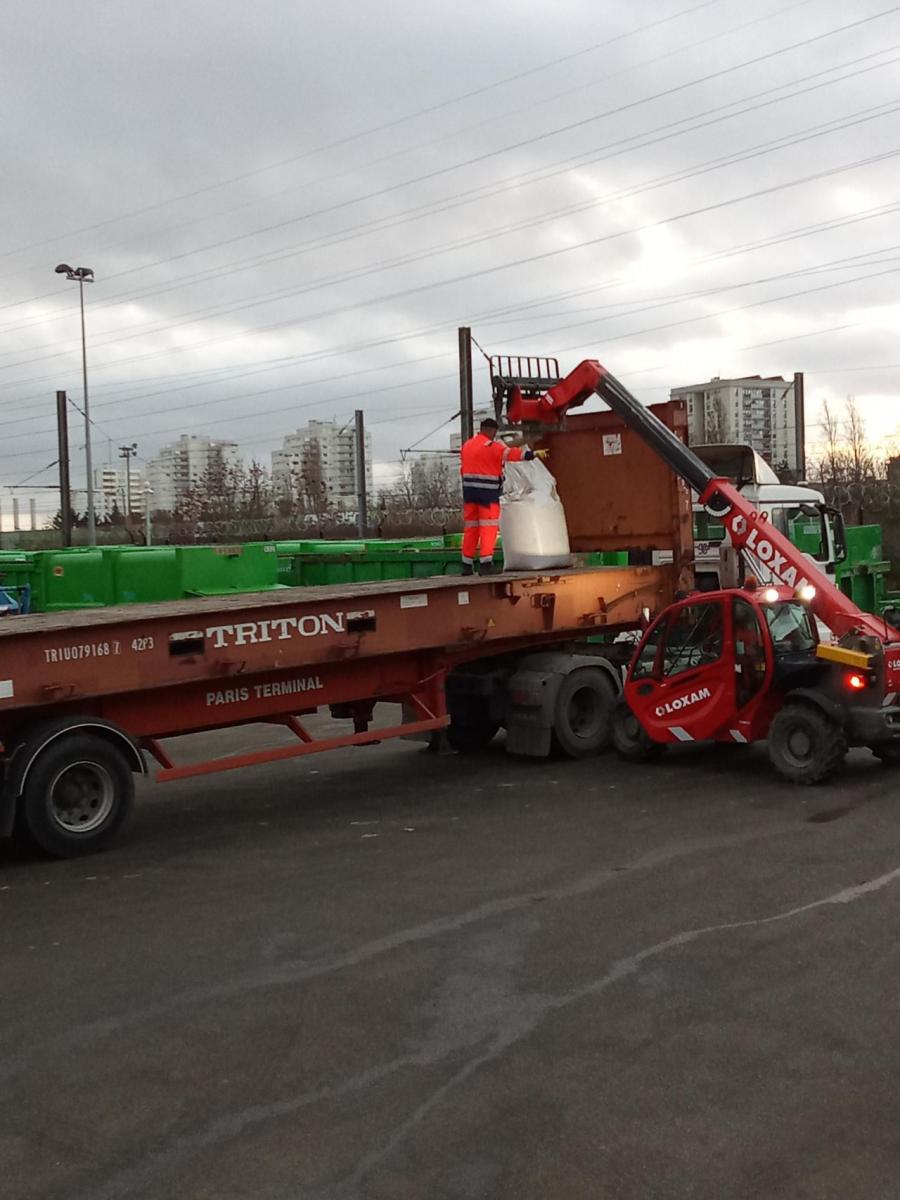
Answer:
top-left (0, 731), bottom-right (900, 1200)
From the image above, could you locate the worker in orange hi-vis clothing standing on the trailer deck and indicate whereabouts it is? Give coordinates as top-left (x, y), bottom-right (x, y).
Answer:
top-left (460, 418), bottom-right (547, 575)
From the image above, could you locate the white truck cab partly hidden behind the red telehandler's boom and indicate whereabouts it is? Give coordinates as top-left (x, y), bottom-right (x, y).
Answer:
top-left (691, 443), bottom-right (846, 592)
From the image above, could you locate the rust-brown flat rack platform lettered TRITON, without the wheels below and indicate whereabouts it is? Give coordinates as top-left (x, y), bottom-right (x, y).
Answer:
top-left (0, 566), bottom-right (670, 710)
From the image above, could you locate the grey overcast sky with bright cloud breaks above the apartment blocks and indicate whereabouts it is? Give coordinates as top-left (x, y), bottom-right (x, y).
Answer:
top-left (0, 0), bottom-right (900, 511)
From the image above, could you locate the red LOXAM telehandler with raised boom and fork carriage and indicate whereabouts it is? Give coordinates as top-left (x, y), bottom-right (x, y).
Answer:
top-left (492, 359), bottom-right (900, 784)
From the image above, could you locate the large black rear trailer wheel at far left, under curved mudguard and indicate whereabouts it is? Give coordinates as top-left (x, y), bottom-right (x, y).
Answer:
top-left (16, 733), bottom-right (134, 858)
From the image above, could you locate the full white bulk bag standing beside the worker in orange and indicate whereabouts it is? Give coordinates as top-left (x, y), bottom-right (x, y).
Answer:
top-left (500, 458), bottom-right (571, 571)
